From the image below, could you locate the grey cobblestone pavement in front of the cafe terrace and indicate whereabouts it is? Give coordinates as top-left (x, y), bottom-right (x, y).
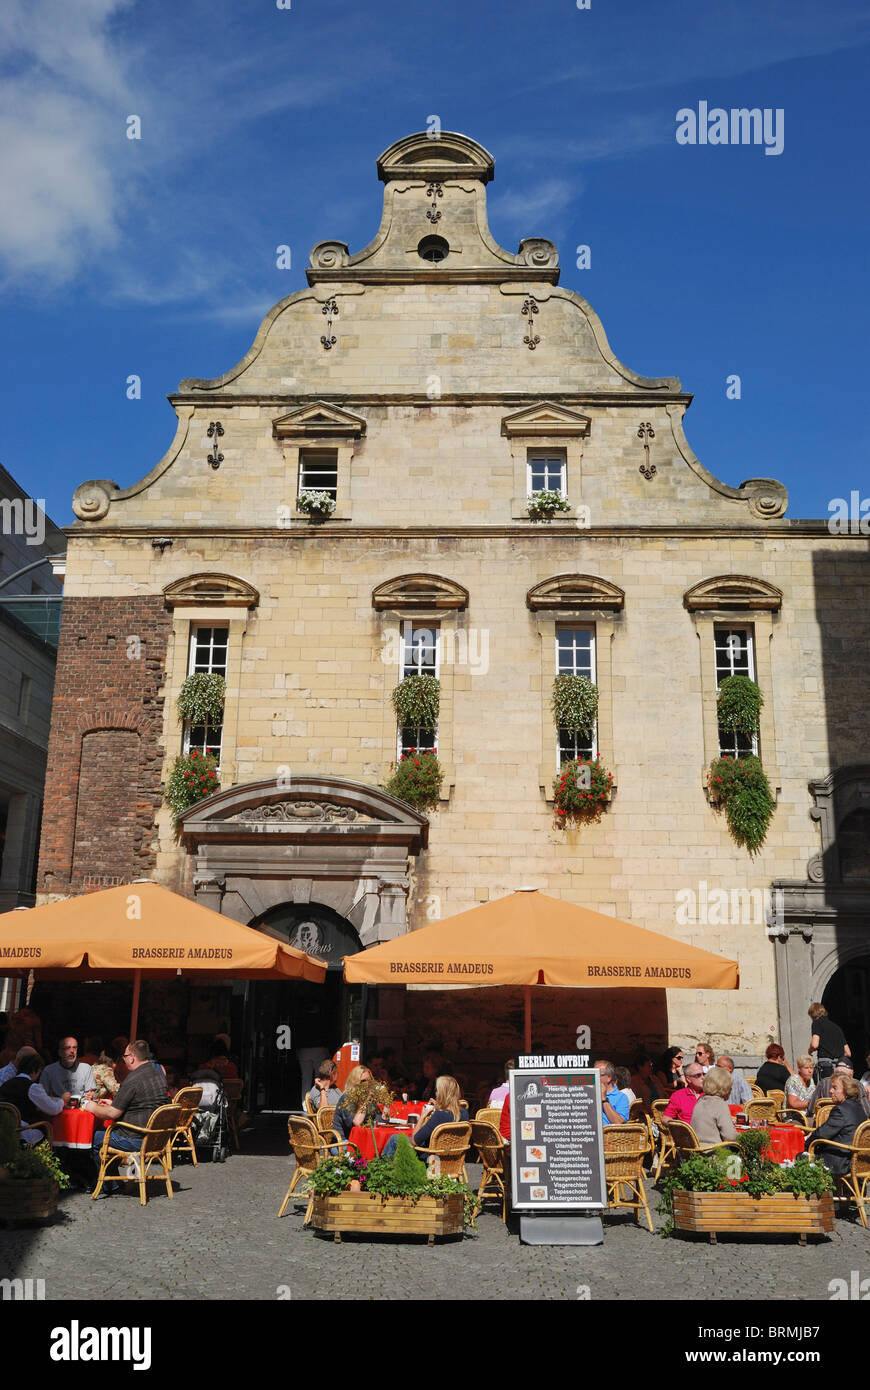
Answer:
top-left (0, 1145), bottom-right (870, 1304)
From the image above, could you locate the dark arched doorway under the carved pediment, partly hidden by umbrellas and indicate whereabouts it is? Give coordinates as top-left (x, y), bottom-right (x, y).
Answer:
top-left (243, 902), bottom-right (363, 1113)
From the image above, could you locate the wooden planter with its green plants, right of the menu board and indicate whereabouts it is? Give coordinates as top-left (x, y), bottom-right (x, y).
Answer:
top-left (659, 1129), bottom-right (834, 1244)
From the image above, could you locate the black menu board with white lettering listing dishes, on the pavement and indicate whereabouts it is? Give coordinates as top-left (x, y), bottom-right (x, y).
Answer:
top-left (509, 1068), bottom-right (607, 1211)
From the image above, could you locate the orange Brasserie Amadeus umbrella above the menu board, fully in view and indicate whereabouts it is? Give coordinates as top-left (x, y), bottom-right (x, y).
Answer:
top-left (345, 888), bottom-right (739, 1052)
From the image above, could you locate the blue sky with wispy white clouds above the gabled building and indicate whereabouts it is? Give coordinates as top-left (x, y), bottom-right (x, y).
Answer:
top-left (0, 0), bottom-right (870, 524)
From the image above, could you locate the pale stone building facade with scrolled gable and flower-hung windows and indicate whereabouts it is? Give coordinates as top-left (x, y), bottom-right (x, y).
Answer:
top-left (33, 132), bottom-right (870, 1089)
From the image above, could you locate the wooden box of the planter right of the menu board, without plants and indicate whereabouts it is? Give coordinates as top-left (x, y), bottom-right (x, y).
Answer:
top-left (674, 1190), bottom-right (834, 1245)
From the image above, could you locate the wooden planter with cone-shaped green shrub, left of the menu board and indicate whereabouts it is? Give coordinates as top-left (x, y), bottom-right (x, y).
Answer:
top-left (309, 1134), bottom-right (478, 1244)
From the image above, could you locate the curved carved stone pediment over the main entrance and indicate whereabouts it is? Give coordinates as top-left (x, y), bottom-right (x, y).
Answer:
top-left (179, 776), bottom-right (429, 853)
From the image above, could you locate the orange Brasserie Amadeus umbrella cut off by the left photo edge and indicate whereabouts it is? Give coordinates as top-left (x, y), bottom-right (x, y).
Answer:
top-left (0, 880), bottom-right (327, 1037)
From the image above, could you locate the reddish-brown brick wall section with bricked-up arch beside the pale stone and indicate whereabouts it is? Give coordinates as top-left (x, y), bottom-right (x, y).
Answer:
top-left (38, 596), bottom-right (171, 894)
